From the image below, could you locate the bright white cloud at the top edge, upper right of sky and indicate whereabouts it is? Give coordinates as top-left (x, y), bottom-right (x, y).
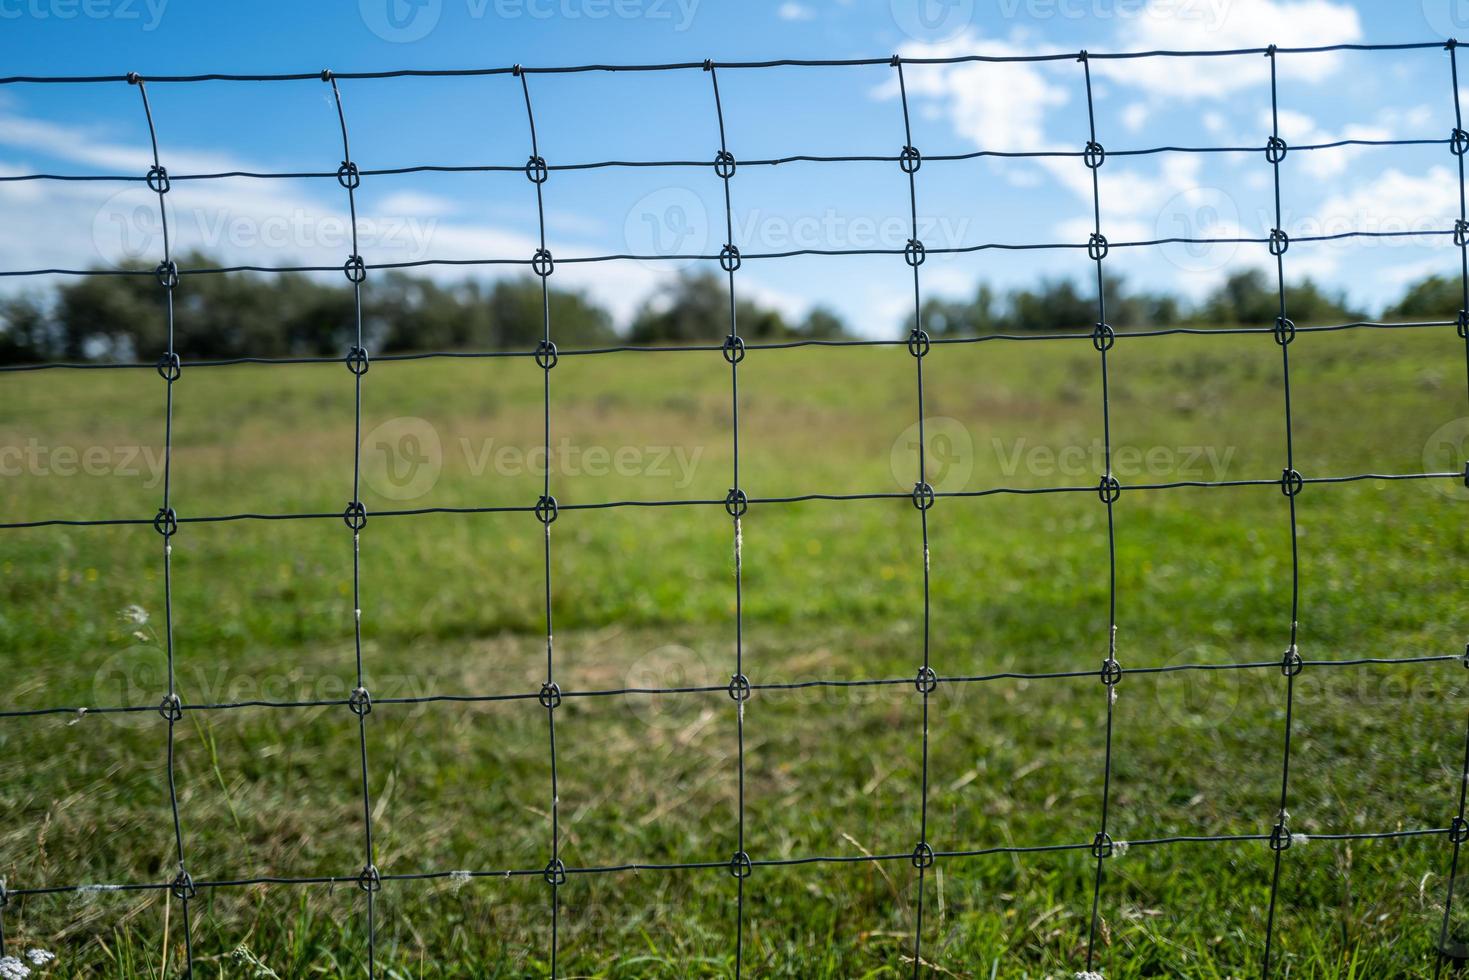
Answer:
top-left (1091, 0), bottom-right (1362, 98)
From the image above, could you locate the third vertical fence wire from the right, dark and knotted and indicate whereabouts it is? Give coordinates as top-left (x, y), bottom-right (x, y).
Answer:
top-left (1077, 51), bottom-right (1122, 973)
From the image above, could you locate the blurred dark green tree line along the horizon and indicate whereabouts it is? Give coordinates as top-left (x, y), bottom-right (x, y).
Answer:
top-left (0, 256), bottom-right (1460, 364)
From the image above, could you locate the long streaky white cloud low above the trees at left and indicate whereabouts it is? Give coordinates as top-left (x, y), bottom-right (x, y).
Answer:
top-left (0, 115), bottom-right (681, 323)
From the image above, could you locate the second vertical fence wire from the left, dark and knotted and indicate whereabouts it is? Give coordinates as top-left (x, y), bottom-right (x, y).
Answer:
top-left (322, 71), bottom-right (382, 977)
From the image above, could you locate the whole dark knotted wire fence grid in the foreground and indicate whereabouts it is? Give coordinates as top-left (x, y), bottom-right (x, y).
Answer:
top-left (0, 40), bottom-right (1469, 977)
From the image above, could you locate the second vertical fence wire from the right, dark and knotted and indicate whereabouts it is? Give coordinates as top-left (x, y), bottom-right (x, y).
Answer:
top-left (1263, 44), bottom-right (1304, 977)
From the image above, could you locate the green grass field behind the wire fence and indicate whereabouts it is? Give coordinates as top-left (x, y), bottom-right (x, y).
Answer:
top-left (0, 328), bottom-right (1469, 979)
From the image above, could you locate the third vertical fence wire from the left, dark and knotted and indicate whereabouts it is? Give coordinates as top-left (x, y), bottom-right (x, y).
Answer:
top-left (516, 65), bottom-right (566, 980)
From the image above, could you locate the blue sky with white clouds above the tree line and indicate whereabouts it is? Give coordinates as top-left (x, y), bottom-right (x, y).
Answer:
top-left (0, 0), bottom-right (1469, 335)
